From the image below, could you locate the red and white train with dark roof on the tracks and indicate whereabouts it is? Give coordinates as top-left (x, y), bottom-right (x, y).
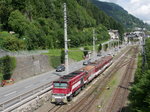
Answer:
top-left (51, 56), bottom-right (112, 104)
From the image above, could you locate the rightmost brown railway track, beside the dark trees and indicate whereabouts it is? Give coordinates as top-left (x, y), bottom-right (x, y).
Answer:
top-left (107, 48), bottom-right (137, 112)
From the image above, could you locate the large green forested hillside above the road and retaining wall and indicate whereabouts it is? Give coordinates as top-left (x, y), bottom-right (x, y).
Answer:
top-left (0, 0), bottom-right (123, 51)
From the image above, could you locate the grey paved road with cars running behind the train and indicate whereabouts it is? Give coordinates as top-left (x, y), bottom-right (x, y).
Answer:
top-left (0, 44), bottom-right (125, 103)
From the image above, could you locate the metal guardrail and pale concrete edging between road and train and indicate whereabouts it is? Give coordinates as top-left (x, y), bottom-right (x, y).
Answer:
top-left (0, 82), bottom-right (52, 112)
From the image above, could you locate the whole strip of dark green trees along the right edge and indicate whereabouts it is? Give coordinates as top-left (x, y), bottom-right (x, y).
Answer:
top-left (129, 39), bottom-right (150, 112)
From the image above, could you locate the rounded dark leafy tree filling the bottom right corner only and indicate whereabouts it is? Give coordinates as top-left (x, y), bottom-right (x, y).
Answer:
top-left (129, 71), bottom-right (150, 112)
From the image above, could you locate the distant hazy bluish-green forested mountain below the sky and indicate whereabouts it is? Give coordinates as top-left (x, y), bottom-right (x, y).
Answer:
top-left (90, 0), bottom-right (150, 29)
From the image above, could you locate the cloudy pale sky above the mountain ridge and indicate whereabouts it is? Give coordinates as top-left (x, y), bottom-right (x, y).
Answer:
top-left (99, 0), bottom-right (150, 24)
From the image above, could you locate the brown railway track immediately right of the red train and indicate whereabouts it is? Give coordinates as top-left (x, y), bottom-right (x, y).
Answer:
top-left (66, 46), bottom-right (136, 112)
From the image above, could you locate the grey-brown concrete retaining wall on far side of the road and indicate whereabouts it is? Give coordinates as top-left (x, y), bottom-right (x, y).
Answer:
top-left (12, 55), bottom-right (53, 81)
